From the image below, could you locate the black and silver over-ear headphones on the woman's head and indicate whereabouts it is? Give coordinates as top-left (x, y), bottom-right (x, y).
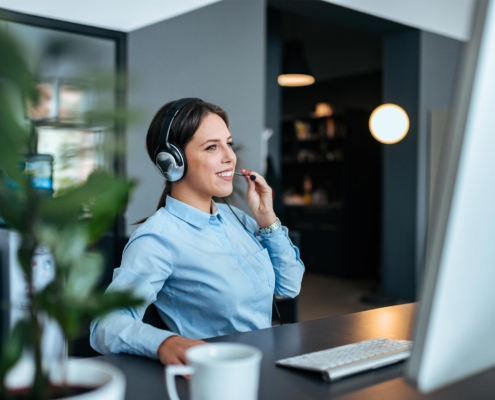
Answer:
top-left (155, 97), bottom-right (201, 182)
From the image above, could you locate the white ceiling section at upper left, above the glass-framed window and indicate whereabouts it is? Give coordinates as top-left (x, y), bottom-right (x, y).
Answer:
top-left (0, 0), bottom-right (220, 32)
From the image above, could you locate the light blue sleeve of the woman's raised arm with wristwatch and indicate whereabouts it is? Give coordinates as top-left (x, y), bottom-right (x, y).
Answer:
top-left (236, 209), bottom-right (305, 297)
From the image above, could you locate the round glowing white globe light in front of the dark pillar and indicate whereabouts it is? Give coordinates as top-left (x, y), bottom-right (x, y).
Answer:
top-left (369, 104), bottom-right (409, 144)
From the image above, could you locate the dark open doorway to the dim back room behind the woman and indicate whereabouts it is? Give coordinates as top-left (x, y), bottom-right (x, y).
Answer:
top-left (266, 1), bottom-right (409, 320)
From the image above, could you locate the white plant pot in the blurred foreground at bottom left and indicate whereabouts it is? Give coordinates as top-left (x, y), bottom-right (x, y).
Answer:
top-left (6, 358), bottom-right (126, 400)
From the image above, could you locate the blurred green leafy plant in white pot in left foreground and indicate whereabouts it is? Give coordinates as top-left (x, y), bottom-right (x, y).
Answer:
top-left (0, 33), bottom-right (141, 399)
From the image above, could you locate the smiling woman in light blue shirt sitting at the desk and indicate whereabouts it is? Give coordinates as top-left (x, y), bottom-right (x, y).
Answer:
top-left (90, 99), bottom-right (304, 365)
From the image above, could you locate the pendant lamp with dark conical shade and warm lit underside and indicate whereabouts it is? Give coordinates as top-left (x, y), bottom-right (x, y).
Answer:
top-left (278, 42), bottom-right (315, 87)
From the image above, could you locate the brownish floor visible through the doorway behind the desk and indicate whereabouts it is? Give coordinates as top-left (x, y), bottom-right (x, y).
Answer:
top-left (298, 273), bottom-right (380, 322)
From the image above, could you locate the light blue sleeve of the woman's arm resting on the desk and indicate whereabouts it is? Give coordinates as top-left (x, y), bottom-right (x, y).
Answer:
top-left (90, 231), bottom-right (176, 359)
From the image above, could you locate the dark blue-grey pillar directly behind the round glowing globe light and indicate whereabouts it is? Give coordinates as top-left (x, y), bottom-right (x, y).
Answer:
top-left (382, 31), bottom-right (420, 300)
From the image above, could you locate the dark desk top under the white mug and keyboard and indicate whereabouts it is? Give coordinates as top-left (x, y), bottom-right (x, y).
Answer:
top-left (100, 304), bottom-right (495, 400)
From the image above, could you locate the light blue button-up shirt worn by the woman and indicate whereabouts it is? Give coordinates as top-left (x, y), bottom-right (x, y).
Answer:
top-left (90, 196), bottom-right (304, 359)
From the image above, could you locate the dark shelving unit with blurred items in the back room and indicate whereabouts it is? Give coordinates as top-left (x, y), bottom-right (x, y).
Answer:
top-left (279, 110), bottom-right (382, 277)
